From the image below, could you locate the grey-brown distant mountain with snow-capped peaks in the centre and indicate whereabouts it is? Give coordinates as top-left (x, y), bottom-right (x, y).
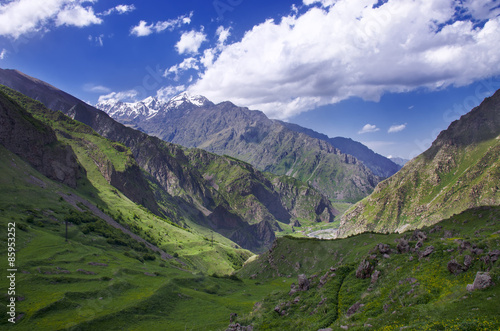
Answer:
top-left (97, 93), bottom-right (382, 202)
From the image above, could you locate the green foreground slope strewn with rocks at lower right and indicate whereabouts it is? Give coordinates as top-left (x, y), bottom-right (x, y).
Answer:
top-left (238, 207), bottom-right (500, 330)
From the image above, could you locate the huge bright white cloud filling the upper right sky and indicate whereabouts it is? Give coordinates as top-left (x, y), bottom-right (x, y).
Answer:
top-left (187, 0), bottom-right (500, 119)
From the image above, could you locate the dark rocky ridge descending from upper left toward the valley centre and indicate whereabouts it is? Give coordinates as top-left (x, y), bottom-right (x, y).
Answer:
top-left (0, 70), bottom-right (338, 251)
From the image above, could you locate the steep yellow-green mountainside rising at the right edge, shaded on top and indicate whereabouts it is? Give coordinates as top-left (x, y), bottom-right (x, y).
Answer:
top-left (339, 90), bottom-right (500, 236)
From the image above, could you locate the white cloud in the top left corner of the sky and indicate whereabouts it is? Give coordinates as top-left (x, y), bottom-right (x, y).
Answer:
top-left (0, 0), bottom-right (102, 39)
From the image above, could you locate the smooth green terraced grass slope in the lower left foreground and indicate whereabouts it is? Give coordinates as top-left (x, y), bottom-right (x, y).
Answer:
top-left (0, 147), bottom-right (289, 330)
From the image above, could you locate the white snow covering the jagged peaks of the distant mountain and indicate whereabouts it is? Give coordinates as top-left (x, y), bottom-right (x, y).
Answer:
top-left (95, 92), bottom-right (210, 121)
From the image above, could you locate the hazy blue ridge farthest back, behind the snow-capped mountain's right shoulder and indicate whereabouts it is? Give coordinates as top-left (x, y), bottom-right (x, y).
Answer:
top-left (282, 122), bottom-right (401, 178)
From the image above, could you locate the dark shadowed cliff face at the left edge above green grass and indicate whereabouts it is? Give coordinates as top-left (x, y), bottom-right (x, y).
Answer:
top-left (0, 92), bottom-right (84, 188)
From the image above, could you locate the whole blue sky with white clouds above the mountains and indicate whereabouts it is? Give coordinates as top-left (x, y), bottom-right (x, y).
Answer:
top-left (0, 0), bottom-right (500, 159)
